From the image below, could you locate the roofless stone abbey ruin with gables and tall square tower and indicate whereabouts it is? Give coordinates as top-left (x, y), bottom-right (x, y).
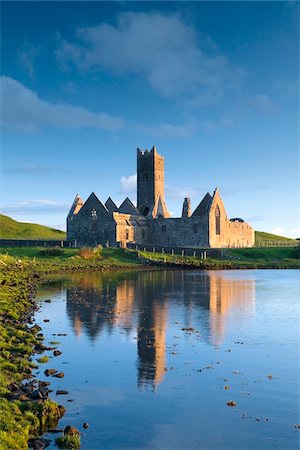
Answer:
top-left (67, 147), bottom-right (254, 248)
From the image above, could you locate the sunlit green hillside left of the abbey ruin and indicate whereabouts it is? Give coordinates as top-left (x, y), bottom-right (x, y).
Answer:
top-left (0, 214), bottom-right (66, 240)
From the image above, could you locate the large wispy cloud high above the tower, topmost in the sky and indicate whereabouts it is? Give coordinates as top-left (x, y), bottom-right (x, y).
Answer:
top-left (56, 12), bottom-right (244, 103)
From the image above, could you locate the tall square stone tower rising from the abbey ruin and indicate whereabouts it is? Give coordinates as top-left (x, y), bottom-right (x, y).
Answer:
top-left (137, 147), bottom-right (165, 216)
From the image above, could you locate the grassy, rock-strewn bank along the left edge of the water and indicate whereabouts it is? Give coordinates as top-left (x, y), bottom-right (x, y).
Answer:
top-left (0, 247), bottom-right (139, 450)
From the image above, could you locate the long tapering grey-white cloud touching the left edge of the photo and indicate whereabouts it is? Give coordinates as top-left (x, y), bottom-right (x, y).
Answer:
top-left (0, 76), bottom-right (124, 132)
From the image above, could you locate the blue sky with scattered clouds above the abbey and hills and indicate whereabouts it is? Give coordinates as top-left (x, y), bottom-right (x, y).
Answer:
top-left (1, 1), bottom-right (300, 237)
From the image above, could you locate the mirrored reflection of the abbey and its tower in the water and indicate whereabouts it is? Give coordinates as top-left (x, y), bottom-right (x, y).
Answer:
top-left (67, 271), bottom-right (255, 388)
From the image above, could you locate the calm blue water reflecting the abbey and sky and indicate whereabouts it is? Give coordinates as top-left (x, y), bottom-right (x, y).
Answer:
top-left (36, 270), bottom-right (300, 450)
